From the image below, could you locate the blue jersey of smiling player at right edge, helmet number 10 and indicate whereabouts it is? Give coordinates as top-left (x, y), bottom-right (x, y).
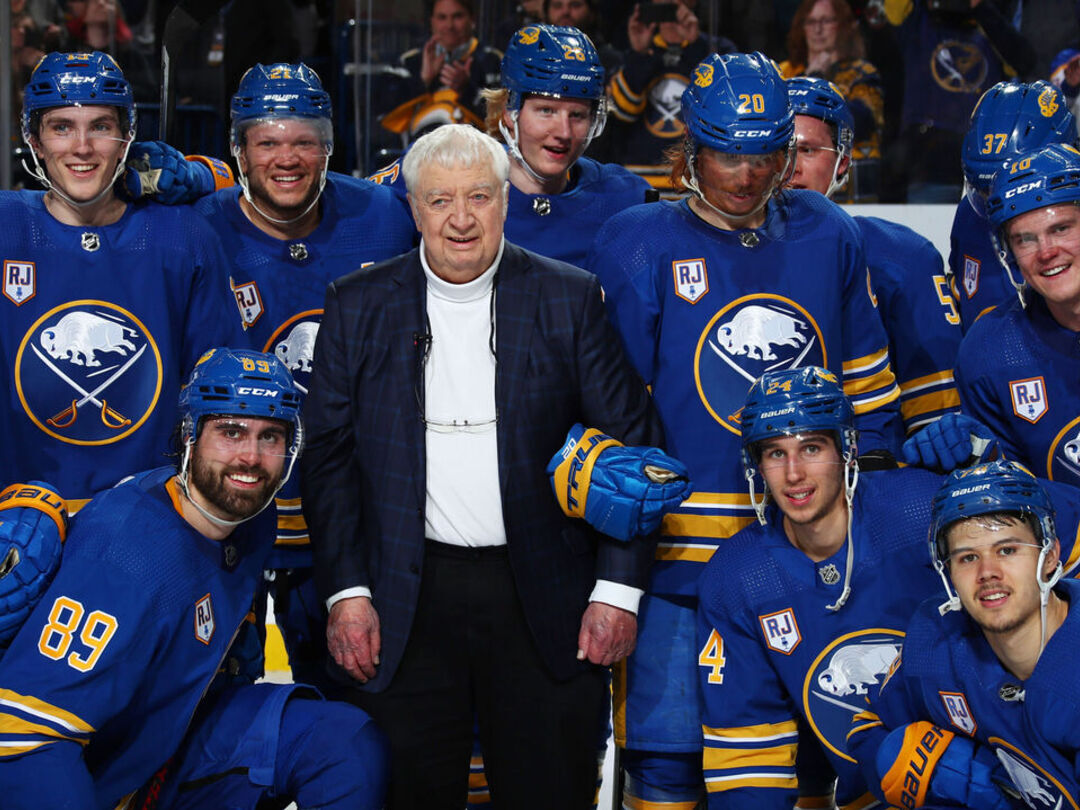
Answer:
top-left (956, 289), bottom-right (1080, 486)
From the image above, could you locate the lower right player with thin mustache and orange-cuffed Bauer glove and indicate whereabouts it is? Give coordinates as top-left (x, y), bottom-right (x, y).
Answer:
top-left (848, 462), bottom-right (1080, 810)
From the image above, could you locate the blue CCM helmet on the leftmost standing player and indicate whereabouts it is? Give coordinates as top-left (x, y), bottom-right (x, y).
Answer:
top-left (22, 51), bottom-right (135, 145)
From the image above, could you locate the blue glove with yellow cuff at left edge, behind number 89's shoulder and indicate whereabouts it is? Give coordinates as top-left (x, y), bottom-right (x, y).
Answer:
top-left (0, 482), bottom-right (67, 650)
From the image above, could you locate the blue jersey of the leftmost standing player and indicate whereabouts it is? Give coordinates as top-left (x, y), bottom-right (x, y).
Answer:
top-left (0, 192), bottom-right (239, 511)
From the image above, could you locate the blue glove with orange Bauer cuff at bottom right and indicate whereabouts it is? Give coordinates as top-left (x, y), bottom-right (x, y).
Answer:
top-left (876, 720), bottom-right (1013, 810)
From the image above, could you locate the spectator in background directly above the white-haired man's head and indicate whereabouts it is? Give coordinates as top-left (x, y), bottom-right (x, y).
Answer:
top-left (382, 0), bottom-right (502, 144)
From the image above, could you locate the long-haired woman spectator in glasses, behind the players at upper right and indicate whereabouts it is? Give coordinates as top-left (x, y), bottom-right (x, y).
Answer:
top-left (780, 0), bottom-right (885, 202)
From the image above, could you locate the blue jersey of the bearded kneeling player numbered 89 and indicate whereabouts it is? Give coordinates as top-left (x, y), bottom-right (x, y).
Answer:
top-left (0, 468), bottom-right (273, 810)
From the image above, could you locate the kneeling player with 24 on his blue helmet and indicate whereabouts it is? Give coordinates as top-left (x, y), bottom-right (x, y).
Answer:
top-left (697, 366), bottom-right (941, 810)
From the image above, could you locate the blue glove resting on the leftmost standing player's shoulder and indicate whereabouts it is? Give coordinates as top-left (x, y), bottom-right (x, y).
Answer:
top-left (124, 140), bottom-right (233, 205)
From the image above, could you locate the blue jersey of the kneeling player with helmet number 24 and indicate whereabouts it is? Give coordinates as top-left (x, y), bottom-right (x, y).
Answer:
top-left (697, 469), bottom-right (942, 810)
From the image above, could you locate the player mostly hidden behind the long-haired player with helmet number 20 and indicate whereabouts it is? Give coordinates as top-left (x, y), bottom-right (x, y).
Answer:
top-left (787, 76), bottom-right (961, 434)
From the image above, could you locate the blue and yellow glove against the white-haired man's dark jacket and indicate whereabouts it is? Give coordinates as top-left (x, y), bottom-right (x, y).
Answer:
top-left (548, 423), bottom-right (691, 541)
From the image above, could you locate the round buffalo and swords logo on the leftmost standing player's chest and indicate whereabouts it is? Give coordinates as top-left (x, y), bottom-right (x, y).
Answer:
top-left (15, 300), bottom-right (162, 445)
